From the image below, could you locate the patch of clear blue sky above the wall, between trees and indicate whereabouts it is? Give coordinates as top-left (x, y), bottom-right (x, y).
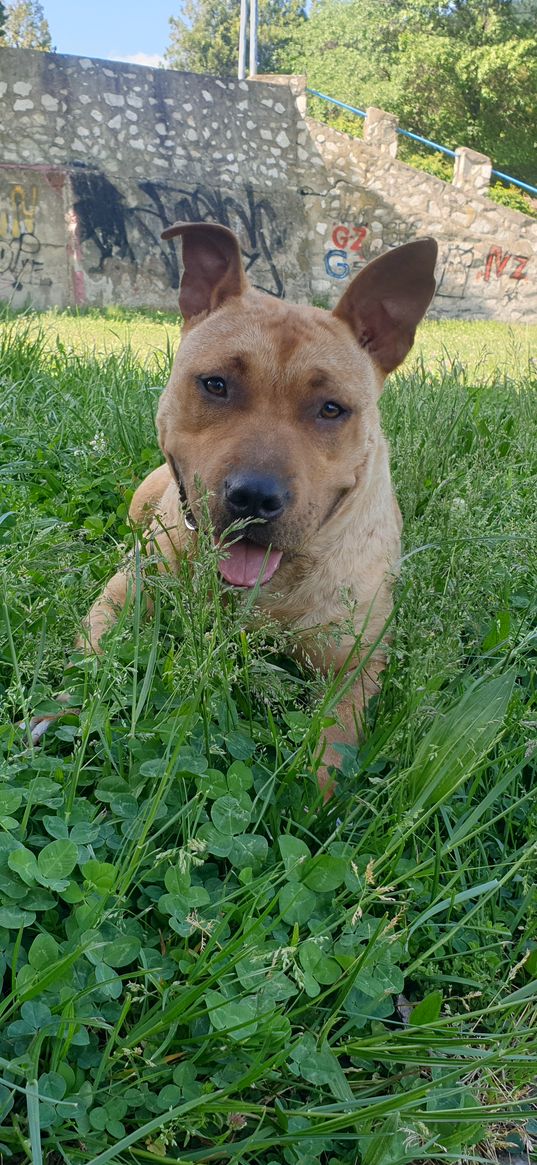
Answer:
top-left (42, 0), bottom-right (175, 65)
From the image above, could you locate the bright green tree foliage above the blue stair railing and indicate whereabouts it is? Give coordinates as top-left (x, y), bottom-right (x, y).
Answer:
top-left (280, 0), bottom-right (537, 184)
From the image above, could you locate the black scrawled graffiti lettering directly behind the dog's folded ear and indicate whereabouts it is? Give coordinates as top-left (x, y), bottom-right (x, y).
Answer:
top-left (129, 182), bottom-right (285, 298)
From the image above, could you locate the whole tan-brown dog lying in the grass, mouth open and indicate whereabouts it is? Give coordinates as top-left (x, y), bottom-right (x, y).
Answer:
top-left (28, 223), bottom-right (437, 783)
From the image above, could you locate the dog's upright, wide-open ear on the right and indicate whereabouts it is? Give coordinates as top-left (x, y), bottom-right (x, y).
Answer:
top-left (333, 239), bottom-right (438, 374)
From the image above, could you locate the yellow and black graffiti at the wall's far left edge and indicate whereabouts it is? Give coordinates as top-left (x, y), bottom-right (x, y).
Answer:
top-left (0, 185), bottom-right (43, 291)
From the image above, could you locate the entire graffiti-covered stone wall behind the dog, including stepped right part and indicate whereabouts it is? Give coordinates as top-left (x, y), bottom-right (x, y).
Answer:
top-left (0, 49), bottom-right (537, 320)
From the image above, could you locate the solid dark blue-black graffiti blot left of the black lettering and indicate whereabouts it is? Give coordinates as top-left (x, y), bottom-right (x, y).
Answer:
top-left (71, 168), bottom-right (135, 273)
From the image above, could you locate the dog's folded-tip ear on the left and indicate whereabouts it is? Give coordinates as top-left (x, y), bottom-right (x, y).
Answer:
top-left (161, 223), bottom-right (248, 322)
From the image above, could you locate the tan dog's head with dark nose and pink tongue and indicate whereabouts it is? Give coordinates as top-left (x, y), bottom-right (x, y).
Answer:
top-left (157, 223), bottom-right (437, 586)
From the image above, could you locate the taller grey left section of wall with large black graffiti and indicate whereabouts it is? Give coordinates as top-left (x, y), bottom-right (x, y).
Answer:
top-left (0, 49), bottom-right (310, 309)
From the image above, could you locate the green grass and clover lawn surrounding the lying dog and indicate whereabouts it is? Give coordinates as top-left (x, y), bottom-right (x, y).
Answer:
top-left (0, 317), bottom-right (537, 1165)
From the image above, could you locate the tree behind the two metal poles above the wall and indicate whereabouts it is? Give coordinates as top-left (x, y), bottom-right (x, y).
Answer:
top-left (164, 0), bottom-right (305, 77)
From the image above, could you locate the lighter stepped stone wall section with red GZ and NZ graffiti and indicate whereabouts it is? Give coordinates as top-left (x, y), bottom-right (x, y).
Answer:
top-left (302, 110), bottom-right (537, 323)
